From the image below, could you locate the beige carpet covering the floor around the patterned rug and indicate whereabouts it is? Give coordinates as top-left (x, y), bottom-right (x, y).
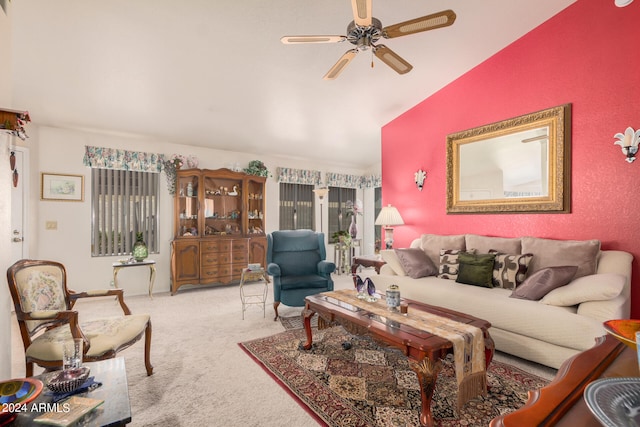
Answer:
top-left (12, 275), bottom-right (555, 427)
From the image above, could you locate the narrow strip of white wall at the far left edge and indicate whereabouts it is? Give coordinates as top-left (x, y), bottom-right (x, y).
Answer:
top-left (0, 2), bottom-right (12, 379)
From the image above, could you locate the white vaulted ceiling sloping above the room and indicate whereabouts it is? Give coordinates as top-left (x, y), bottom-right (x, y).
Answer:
top-left (11, 0), bottom-right (576, 169)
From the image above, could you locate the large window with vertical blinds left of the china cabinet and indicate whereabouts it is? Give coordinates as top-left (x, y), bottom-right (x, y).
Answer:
top-left (91, 168), bottom-right (160, 256)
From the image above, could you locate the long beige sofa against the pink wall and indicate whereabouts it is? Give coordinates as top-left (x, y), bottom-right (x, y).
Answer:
top-left (369, 234), bottom-right (633, 368)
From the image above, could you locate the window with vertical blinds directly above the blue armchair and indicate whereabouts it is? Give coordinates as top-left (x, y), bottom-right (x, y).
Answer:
top-left (280, 183), bottom-right (315, 230)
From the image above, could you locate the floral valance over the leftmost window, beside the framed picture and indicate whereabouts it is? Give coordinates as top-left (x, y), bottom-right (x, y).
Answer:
top-left (83, 145), bottom-right (165, 173)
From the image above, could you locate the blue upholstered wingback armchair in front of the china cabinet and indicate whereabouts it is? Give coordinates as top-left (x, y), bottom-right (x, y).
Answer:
top-left (267, 230), bottom-right (336, 320)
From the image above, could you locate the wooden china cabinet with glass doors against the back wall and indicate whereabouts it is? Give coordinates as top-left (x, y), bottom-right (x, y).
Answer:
top-left (171, 169), bottom-right (267, 295)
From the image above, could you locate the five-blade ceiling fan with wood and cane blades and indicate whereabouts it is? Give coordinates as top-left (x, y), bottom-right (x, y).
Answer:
top-left (280, 0), bottom-right (456, 80)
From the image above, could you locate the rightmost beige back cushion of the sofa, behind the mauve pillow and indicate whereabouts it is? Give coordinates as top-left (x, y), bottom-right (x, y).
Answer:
top-left (522, 237), bottom-right (600, 278)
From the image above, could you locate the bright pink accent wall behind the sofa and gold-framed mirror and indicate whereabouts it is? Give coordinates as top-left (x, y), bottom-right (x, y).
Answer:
top-left (382, 0), bottom-right (640, 318)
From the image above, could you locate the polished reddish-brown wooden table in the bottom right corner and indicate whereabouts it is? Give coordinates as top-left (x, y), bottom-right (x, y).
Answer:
top-left (490, 335), bottom-right (638, 427)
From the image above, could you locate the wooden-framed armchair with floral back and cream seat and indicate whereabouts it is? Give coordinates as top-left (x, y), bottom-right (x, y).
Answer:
top-left (7, 260), bottom-right (153, 376)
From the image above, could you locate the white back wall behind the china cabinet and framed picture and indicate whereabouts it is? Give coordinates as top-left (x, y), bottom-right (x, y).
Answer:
top-left (29, 125), bottom-right (373, 295)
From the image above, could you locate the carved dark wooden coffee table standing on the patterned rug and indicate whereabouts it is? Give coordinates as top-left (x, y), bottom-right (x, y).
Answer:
top-left (303, 290), bottom-right (494, 426)
